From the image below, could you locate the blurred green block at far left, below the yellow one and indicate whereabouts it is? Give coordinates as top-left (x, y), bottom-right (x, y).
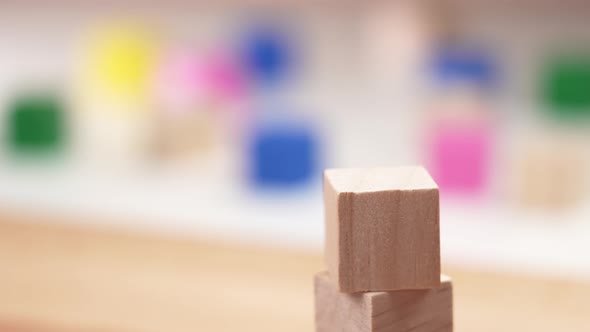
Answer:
top-left (7, 95), bottom-right (65, 153)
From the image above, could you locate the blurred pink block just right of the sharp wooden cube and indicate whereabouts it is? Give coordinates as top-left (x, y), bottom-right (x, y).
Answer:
top-left (429, 119), bottom-right (492, 194)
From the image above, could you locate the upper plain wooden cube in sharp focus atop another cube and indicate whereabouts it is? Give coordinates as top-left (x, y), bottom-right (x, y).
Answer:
top-left (324, 167), bottom-right (440, 293)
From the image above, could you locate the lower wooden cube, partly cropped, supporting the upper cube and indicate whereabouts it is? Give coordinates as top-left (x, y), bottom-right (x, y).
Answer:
top-left (315, 272), bottom-right (453, 332)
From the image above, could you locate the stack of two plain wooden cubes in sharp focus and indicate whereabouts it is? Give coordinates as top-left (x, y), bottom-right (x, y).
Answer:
top-left (315, 167), bottom-right (453, 332)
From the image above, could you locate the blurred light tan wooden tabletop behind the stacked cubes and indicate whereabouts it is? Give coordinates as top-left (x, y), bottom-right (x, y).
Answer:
top-left (0, 213), bottom-right (590, 332)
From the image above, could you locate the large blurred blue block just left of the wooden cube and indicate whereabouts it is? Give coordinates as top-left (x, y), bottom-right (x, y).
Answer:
top-left (249, 125), bottom-right (319, 187)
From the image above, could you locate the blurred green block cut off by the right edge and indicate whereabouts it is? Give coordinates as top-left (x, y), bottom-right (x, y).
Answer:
top-left (542, 55), bottom-right (590, 116)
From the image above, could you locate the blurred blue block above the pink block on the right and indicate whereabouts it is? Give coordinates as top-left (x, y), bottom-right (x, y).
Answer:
top-left (432, 45), bottom-right (498, 90)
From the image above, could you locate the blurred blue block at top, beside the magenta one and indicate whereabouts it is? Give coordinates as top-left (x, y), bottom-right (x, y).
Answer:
top-left (242, 24), bottom-right (294, 84)
